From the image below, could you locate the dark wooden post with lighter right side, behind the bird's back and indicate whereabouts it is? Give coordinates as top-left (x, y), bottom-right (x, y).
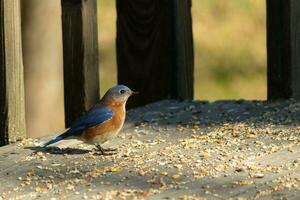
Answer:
top-left (62, 0), bottom-right (99, 126)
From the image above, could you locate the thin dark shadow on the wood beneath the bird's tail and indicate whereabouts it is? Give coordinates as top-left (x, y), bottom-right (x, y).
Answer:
top-left (25, 146), bottom-right (93, 155)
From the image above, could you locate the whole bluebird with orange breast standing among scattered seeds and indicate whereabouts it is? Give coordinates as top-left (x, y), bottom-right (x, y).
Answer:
top-left (44, 85), bottom-right (138, 155)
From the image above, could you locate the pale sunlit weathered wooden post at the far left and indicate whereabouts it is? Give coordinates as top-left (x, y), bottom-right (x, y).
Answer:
top-left (0, 0), bottom-right (25, 146)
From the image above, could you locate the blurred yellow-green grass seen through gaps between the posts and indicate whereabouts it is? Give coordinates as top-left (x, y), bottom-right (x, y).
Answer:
top-left (98, 0), bottom-right (267, 100)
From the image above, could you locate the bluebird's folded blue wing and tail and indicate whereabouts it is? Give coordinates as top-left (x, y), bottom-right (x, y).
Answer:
top-left (44, 107), bottom-right (113, 146)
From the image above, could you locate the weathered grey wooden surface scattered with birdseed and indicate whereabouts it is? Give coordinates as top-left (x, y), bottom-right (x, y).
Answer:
top-left (0, 101), bottom-right (300, 199)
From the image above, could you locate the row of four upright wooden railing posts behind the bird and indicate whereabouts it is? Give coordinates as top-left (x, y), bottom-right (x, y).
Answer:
top-left (0, 0), bottom-right (300, 145)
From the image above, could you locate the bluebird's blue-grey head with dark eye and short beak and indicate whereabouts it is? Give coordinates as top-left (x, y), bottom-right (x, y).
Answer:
top-left (103, 85), bottom-right (138, 104)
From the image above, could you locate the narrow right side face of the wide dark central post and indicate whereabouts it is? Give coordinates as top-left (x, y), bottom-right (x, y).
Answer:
top-left (172, 0), bottom-right (194, 99)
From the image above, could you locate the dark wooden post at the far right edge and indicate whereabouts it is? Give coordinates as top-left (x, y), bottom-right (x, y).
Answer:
top-left (267, 0), bottom-right (300, 100)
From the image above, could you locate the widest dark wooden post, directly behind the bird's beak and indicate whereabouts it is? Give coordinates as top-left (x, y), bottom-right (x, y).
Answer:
top-left (117, 0), bottom-right (193, 106)
